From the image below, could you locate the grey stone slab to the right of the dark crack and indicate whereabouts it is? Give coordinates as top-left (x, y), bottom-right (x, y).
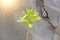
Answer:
top-left (45, 0), bottom-right (60, 40)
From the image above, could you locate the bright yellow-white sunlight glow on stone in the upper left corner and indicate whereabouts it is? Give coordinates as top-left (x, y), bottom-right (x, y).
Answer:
top-left (0, 0), bottom-right (25, 13)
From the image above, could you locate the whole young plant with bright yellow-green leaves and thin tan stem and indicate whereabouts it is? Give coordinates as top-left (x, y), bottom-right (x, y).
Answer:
top-left (17, 8), bottom-right (41, 40)
